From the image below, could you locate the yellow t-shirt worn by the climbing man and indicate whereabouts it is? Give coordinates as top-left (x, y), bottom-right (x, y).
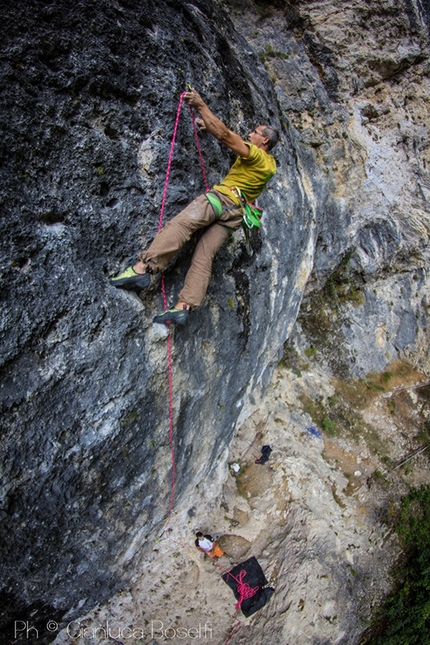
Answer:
top-left (214, 142), bottom-right (276, 205)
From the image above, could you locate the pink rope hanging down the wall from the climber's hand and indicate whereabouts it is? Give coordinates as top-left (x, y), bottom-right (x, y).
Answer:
top-left (158, 92), bottom-right (209, 527)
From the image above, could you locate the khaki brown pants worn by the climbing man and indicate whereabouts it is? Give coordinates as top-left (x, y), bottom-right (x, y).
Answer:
top-left (139, 192), bottom-right (242, 309)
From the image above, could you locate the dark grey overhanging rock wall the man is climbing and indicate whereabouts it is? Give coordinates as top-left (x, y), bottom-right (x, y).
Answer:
top-left (0, 0), bottom-right (316, 631)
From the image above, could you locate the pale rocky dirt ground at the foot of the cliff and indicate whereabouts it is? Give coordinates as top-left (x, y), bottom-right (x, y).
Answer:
top-left (55, 358), bottom-right (429, 645)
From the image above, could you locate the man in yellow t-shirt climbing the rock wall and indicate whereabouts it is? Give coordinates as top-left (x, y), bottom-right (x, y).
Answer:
top-left (110, 90), bottom-right (278, 325)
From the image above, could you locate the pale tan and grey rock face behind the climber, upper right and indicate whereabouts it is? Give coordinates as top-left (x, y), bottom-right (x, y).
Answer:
top-left (231, 0), bottom-right (430, 377)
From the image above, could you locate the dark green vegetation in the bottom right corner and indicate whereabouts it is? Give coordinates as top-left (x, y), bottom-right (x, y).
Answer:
top-left (362, 485), bottom-right (430, 645)
